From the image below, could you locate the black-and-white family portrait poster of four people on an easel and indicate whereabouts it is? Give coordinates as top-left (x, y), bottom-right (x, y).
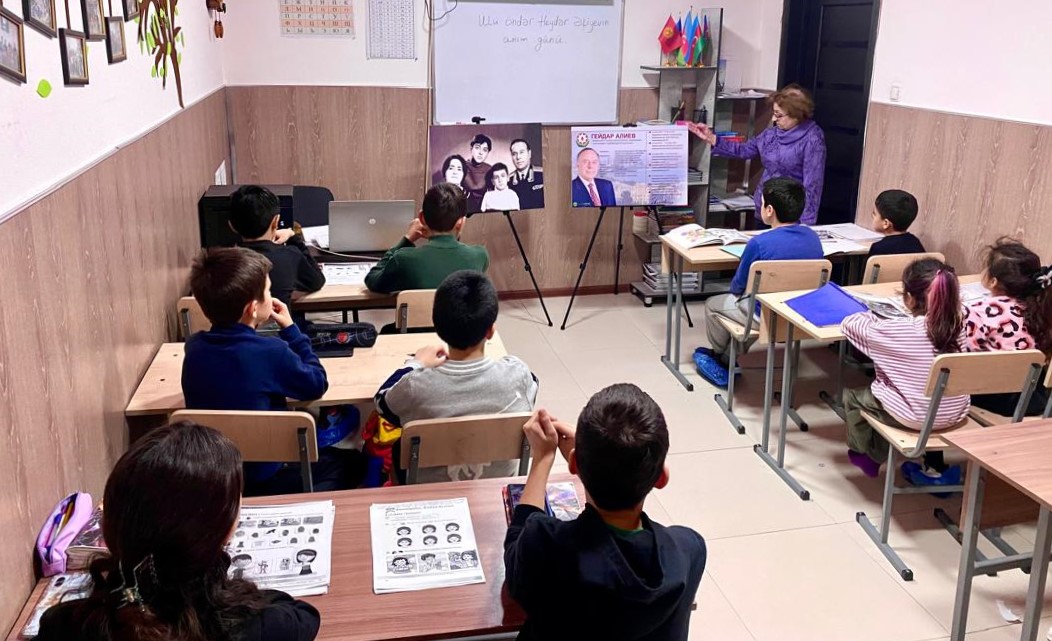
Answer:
top-left (428, 123), bottom-right (544, 214)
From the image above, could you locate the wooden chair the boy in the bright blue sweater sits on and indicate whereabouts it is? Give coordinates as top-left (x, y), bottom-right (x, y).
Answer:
top-left (715, 260), bottom-right (833, 434)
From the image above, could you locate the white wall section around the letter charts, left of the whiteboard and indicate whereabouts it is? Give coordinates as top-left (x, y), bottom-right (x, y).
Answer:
top-left (221, 0), bottom-right (428, 87)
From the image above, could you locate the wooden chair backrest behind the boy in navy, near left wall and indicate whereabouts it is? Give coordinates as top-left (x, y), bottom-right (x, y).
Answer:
top-left (171, 409), bottom-right (318, 493)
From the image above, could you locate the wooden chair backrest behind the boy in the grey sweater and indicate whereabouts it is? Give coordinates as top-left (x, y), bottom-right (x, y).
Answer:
top-left (402, 412), bottom-right (530, 485)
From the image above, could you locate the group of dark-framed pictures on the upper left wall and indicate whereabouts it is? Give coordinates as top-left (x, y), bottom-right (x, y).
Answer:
top-left (0, 0), bottom-right (139, 85)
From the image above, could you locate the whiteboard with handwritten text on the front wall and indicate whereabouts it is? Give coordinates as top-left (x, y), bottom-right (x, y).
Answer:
top-left (432, 0), bottom-right (624, 124)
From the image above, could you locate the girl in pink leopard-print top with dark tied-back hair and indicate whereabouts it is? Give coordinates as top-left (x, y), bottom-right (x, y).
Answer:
top-left (965, 238), bottom-right (1052, 416)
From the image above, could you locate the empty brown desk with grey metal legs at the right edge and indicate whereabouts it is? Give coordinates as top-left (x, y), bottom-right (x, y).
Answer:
top-left (943, 420), bottom-right (1052, 641)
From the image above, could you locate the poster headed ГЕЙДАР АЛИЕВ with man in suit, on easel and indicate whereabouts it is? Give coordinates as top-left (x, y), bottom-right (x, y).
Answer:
top-left (570, 125), bottom-right (688, 207)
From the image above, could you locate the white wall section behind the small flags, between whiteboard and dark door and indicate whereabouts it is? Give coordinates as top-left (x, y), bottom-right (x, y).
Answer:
top-left (621, 0), bottom-right (782, 88)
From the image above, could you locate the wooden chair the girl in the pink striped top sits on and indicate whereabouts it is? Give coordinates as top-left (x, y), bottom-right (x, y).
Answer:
top-left (855, 349), bottom-right (1045, 581)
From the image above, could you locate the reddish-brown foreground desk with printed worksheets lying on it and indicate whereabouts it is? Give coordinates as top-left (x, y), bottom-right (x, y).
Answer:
top-left (7, 474), bottom-right (585, 641)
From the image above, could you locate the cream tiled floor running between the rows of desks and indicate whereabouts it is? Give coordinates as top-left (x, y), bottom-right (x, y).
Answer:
top-left (347, 295), bottom-right (1052, 641)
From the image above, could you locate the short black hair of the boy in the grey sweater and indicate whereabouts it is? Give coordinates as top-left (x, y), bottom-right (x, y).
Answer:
top-left (431, 269), bottom-right (500, 349)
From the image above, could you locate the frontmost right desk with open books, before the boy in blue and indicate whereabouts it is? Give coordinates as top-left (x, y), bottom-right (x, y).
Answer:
top-left (660, 235), bottom-right (871, 392)
